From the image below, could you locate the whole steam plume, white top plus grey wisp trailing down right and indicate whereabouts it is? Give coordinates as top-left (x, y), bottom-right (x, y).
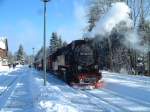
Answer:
top-left (85, 2), bottom-right (149, 53)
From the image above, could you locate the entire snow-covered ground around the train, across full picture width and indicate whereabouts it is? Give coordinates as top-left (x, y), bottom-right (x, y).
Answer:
top-left (0, 67), bottom-right (150, 112)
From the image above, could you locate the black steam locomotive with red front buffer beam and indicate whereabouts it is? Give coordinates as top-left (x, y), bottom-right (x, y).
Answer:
top-left (47, 40), bottom-right (102, 89)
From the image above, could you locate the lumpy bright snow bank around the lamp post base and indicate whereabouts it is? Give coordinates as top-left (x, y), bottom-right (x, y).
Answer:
top-left (31, 71), bottom-right (77, 112)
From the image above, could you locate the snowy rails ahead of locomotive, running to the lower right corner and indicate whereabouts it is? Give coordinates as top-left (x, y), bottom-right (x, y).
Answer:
top-left (86, 90), bottom-right (150, 112)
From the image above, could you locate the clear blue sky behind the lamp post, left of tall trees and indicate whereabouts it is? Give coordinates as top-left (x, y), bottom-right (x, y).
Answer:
top-left (0, 0), bottom-right (86, 54)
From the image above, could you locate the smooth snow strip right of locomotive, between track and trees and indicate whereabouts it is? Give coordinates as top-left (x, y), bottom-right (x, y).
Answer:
top-left (103, 72), bottom-right (150, 102)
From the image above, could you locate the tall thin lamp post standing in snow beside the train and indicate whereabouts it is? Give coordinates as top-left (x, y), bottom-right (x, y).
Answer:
top-left (42, 0), bottom-right (50, 86)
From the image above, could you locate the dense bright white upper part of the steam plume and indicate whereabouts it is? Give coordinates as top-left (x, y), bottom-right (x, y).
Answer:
top-left (91, 2), bottom-right (133, 37)
